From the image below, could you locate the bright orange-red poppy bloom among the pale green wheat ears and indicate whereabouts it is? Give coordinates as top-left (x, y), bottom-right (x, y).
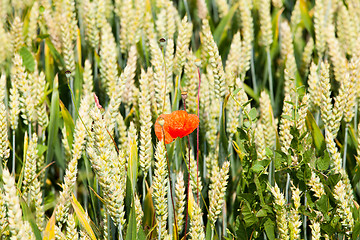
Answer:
top-left (155, 110), bottom-right (200, 144)
